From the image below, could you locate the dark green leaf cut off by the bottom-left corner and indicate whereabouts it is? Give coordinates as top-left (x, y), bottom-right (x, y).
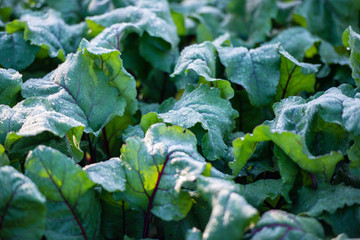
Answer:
top-left (0, 166), bottom-right (46, 239)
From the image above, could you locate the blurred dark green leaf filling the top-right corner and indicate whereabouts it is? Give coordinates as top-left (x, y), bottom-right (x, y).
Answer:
top-left (295, 0), bottom-right (360, 46)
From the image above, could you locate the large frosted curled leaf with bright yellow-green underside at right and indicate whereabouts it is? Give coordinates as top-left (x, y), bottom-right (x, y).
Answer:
top-left (232, 85), bottom-right (359, 176)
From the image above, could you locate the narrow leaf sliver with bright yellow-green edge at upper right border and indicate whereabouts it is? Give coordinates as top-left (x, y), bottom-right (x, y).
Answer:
top-left (343, 26), bottom-right (360, 86)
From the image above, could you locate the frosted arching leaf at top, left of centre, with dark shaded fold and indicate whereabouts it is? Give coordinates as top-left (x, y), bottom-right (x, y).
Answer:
top-left (86, 0), bottom-right (179, 72)
